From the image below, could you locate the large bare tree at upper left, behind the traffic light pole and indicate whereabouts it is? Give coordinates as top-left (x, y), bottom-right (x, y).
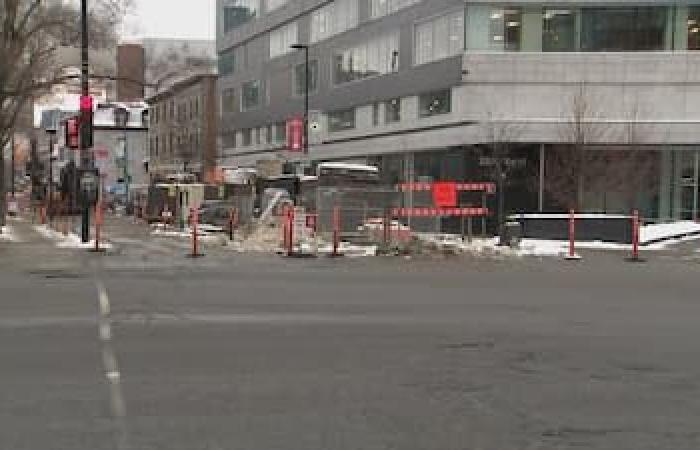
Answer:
top-left (0, 0), bottom-right (130, 224)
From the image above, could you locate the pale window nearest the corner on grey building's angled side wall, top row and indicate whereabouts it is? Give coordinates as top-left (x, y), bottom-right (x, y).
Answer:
top-left (414, 10), bottom-right (464, 64)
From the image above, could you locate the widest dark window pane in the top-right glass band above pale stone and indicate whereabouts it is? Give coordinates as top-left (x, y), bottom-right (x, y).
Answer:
top-left (581, 6), bottom-right (668, 52)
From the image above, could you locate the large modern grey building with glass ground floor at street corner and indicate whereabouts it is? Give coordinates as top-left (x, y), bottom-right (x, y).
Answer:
top-left (217, 0), bottom-right (700, 219)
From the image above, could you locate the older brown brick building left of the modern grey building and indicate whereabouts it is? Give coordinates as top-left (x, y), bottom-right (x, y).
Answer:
top-left (147, 73), bottom-right (218, 180)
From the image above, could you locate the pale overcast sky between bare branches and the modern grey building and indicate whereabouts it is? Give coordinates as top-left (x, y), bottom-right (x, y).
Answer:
top-left (123, 0), bottom-right (216, 39)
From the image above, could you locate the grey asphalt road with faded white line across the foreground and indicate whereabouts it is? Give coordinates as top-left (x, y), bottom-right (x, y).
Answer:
top-left (0, 216), bottom-right (700, 450)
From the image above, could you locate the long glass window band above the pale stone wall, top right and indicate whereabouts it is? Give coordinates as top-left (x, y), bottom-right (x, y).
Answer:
top-left (462, 3), bottom-right (700, 51)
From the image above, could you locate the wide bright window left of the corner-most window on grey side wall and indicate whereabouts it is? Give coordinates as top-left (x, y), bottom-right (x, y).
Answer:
top-left (333, 33), bottom-right (399, 84)
